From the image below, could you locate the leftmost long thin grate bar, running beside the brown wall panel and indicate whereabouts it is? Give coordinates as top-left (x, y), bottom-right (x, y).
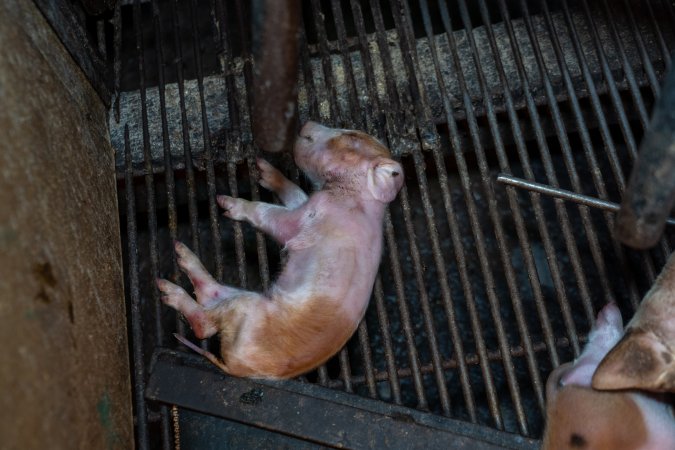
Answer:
top-left (124, 125), bottom-right (148, 450)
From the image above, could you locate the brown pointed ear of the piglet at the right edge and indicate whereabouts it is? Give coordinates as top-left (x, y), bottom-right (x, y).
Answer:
top-left (593, 329), bottom-right (675, 392)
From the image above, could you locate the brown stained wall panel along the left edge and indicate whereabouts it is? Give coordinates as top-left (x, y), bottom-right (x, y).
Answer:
top-left (0, 0), bottom-right (133, 449)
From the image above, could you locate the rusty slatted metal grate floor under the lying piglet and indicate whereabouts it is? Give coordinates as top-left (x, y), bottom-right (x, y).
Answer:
top-left (115, 0), bottom-right (675, 448)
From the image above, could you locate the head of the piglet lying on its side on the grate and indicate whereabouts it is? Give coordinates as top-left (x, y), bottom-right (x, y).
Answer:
top-left (294, 122), bottom-right (403, 203)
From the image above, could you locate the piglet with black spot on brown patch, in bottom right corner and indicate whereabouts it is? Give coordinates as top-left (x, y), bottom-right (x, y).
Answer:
top-left (542, 303), bottom-right (675, 450)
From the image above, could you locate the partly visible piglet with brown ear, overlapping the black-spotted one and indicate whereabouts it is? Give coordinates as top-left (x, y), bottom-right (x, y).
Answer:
top-left (593, 253), bottom-right (675, 394)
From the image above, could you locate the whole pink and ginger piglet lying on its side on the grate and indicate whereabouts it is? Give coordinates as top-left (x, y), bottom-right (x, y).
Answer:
top-left (157, 122), bottom-right (403, 379)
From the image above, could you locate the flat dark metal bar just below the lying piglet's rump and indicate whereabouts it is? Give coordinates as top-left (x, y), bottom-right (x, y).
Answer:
top-left (147, 351), bottom-right (539, 450)
